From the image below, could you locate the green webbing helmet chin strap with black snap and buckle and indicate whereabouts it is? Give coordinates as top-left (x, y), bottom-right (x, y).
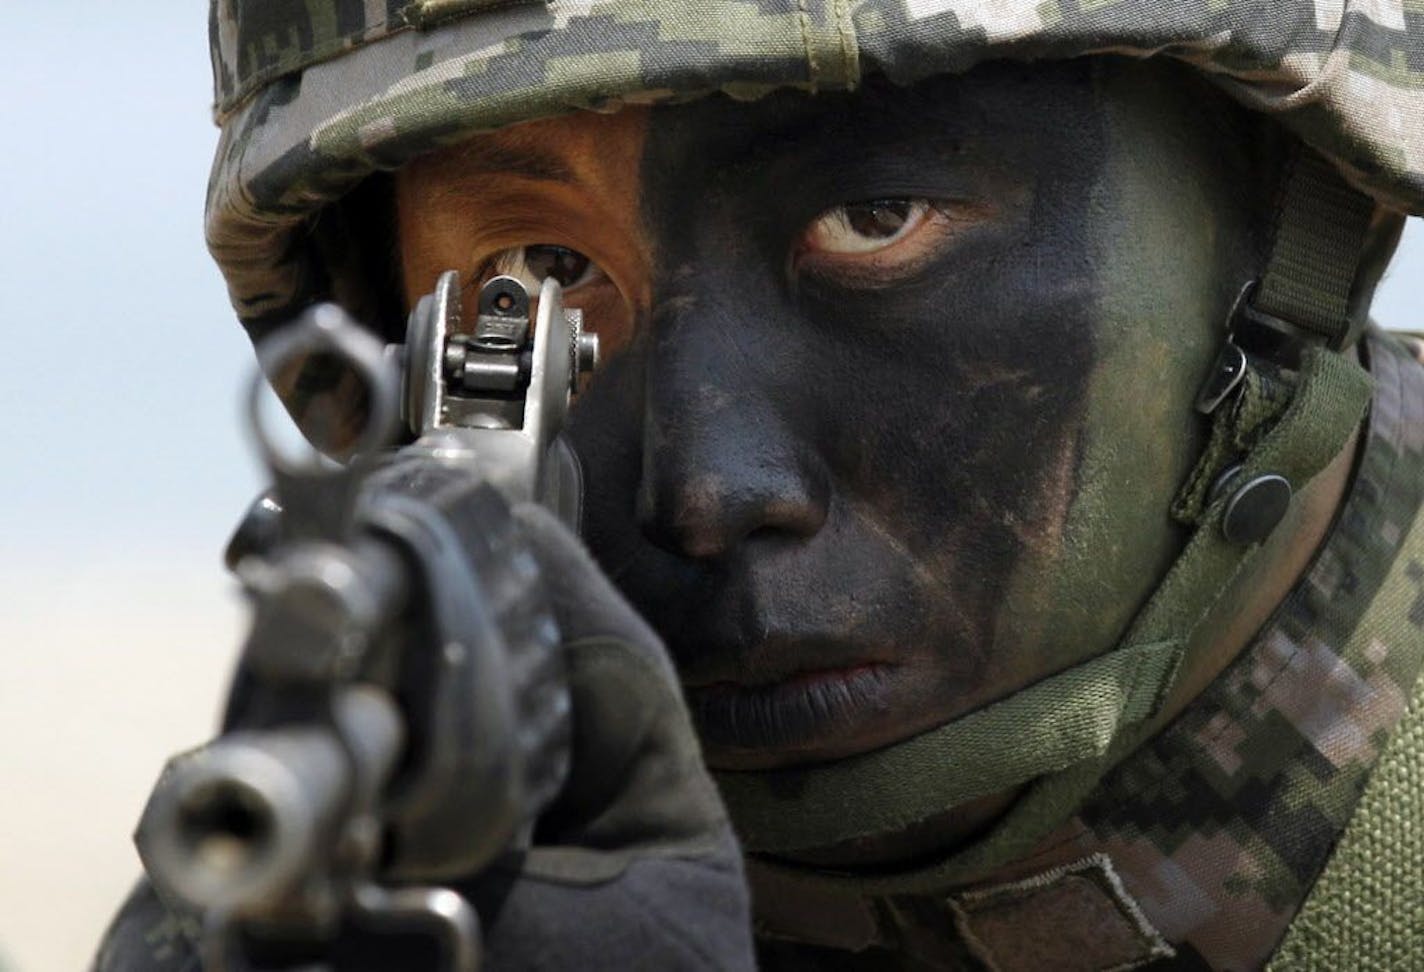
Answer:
top-left (716, 148), bottom-right (1374, 895)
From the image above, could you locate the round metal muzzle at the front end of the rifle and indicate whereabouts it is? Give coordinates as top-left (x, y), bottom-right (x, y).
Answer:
top-left (134, 726), bottom-right (352, 916)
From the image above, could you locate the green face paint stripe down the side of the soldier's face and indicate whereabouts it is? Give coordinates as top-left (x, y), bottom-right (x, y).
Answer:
top-left (995, 61), bottom-right (1274, 691)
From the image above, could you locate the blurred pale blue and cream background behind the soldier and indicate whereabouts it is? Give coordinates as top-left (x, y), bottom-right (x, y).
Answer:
top-left (0, 0), bottom-right (1424, 972)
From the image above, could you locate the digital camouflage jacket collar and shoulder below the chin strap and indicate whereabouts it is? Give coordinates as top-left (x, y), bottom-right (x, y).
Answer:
top-left (762, 334), bottom-right (1424, 972)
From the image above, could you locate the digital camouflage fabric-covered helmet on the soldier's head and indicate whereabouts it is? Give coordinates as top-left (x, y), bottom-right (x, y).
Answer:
top-left (206, 0), bottom-right (1424, 323)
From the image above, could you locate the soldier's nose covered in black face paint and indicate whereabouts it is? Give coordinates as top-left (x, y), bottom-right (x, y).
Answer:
top-left (637, 299), bottom-right (830, 559)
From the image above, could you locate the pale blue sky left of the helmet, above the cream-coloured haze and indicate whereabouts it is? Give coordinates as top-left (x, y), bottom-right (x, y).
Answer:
top-left (0, 7), bottom-right (258, 569)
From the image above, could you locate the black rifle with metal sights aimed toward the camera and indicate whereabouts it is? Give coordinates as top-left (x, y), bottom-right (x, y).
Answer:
top-left (135, 270), bottom-right (598, 972)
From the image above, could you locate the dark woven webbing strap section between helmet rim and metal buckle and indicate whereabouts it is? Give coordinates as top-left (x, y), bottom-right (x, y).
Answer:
top-left (1252, 147), bottom-right (1374, 349)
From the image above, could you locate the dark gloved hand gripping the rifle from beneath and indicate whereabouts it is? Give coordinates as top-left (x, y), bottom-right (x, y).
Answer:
top-left (94, 505), bottom-right (755, 972)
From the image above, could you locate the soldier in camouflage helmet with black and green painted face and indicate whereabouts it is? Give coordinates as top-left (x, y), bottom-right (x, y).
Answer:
top-left (98, 0), bottom-right (1424, 971)
